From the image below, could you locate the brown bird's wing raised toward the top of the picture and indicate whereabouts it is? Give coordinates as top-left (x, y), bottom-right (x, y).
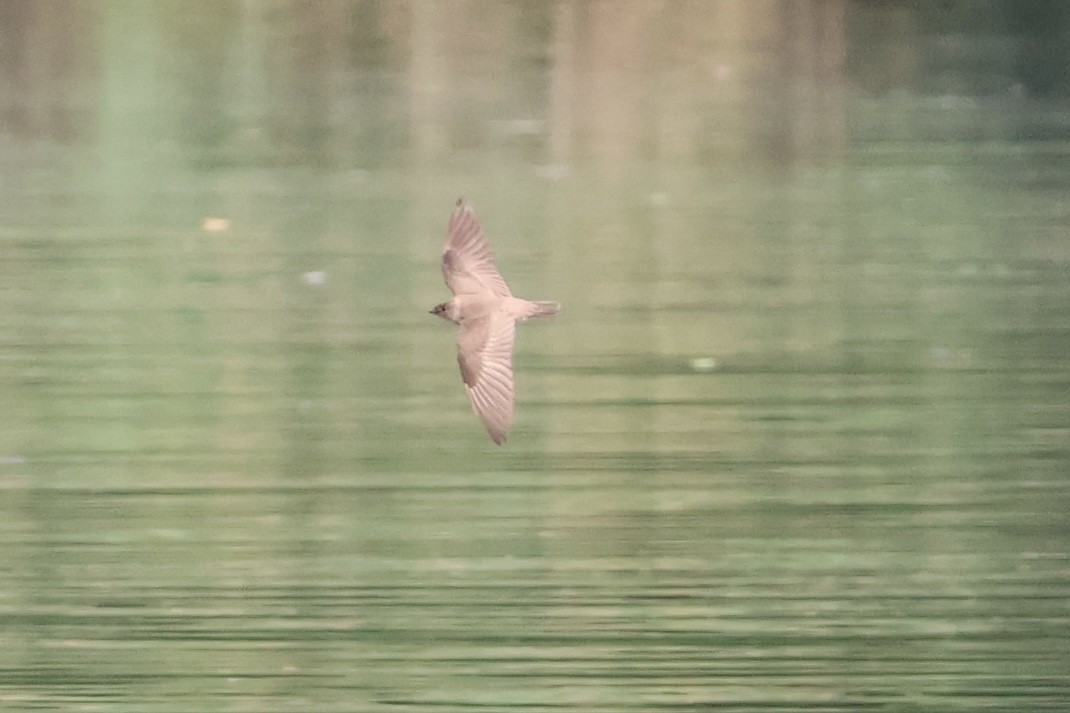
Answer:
top-left (442, 200), bottom-right (511, 297)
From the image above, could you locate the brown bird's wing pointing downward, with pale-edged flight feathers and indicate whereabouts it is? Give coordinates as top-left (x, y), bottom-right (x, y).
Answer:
top-left (457, 313), bottom-right (517, 445)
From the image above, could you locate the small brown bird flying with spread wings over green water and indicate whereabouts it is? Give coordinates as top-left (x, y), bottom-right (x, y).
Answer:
top-left (431, 198), bottom-right (561, 445)
